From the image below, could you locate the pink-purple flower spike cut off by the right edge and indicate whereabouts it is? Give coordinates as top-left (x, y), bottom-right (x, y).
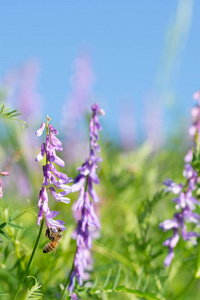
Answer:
top-left (159, 92), bottom-right (200, 266)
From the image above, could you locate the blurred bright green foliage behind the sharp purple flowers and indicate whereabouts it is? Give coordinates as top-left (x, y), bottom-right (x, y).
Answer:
top-left (0, 105), bottom-right (199, 300)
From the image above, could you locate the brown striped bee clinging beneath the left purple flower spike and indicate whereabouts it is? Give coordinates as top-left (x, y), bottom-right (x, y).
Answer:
top-left (43, 228), bottom-right (62, 254)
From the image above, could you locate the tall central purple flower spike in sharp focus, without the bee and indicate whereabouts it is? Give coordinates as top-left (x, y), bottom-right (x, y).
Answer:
top-left (69, 104), bottom-right (104, 299)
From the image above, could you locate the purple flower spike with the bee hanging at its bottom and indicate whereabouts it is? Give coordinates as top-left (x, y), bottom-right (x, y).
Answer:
top-left (35, 116), bottom-right (72, 231)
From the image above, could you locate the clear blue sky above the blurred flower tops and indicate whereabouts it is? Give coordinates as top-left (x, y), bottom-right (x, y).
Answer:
top-left (0, 0), bottom-right (200, 145)
